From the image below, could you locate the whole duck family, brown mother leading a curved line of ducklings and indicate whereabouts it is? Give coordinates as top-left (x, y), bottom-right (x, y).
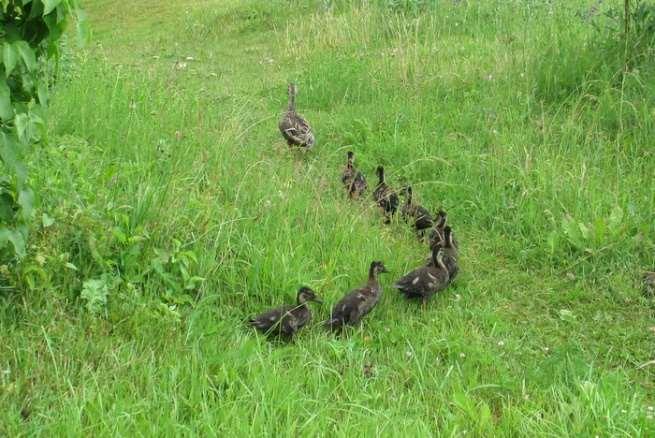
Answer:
top-left (248, 84), bottom-right (459, 339)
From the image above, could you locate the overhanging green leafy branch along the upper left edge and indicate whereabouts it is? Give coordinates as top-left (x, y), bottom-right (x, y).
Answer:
top-left (0, 0), bottom-right (84, 259)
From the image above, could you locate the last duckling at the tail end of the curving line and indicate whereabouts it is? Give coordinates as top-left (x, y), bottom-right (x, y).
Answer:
top-left (248, 286), bottom-right (323, 338)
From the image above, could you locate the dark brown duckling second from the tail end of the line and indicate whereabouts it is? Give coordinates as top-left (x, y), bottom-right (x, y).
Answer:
top-left (325, 261), bottom-right (389, 330)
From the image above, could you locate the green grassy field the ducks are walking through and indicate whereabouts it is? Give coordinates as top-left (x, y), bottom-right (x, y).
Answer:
top-left (0, 0), bottom-right (655, 436)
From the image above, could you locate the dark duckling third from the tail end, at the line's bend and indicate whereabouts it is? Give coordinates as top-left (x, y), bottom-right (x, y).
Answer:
top-left (394, 243), bottom-right (450, 303)
